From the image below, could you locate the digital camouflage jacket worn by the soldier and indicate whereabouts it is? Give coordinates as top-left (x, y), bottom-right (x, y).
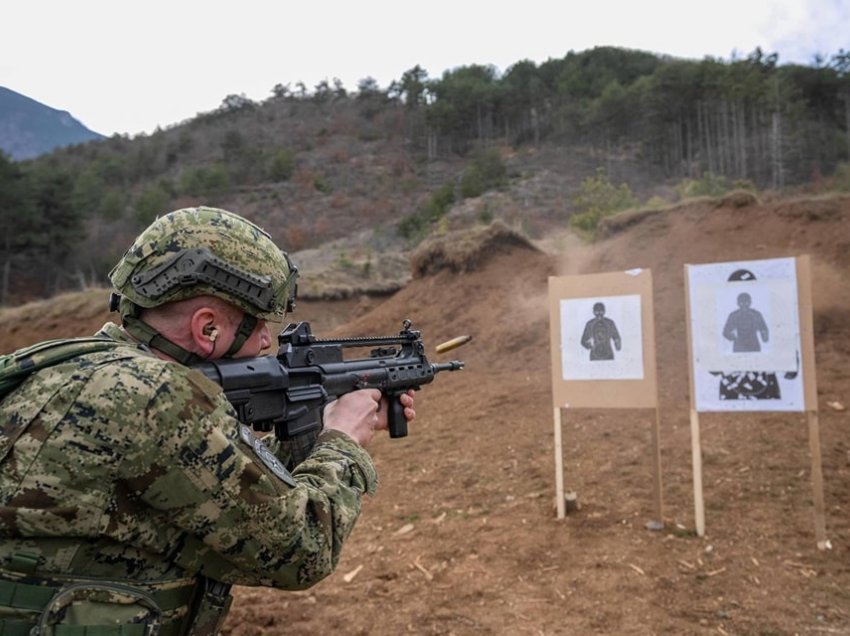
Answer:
top-left (0, 324), bottom-right (377, 632)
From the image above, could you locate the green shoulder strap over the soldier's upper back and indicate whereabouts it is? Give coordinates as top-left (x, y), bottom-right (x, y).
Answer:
top-left (0, 337), bottom-right (135, 399)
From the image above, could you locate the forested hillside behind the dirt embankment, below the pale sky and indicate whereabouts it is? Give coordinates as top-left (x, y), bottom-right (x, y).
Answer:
top-left (0, 48), bottom-right (850, 304)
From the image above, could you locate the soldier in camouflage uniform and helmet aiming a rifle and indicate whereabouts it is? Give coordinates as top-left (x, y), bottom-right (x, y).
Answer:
top-left (0, 207), bottom-right (415, 636)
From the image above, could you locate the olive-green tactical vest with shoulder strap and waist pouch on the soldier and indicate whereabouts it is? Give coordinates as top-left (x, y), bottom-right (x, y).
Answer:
top-left (0, 337), bottom-right (232, 636)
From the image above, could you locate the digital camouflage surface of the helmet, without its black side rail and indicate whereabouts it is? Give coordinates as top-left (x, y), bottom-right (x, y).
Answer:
top-left (109, 206), bottom-right (295, 320)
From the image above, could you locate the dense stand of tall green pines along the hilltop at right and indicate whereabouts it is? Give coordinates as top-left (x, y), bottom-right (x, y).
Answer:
top-left (412, 47), bottom-right (850, 188)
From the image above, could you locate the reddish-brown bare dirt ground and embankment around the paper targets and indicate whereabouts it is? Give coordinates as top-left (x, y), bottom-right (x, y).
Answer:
top-left (0, 197), bottom-right (850, 636)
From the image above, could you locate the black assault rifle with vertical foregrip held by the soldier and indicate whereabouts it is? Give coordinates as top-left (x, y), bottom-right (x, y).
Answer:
top-left (195, 320), bottom-right (470, 440)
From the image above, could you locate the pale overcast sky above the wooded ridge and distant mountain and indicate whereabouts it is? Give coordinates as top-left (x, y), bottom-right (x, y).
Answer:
top-left (0, 0), bottom-right (850, 135)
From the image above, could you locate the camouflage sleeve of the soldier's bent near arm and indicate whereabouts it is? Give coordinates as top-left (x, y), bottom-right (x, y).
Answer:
top-left (115, 365), bottom-right (377, 589)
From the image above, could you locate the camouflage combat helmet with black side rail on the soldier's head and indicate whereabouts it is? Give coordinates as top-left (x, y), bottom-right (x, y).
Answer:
top-left (109, 206), bottom-right (298, 319)
